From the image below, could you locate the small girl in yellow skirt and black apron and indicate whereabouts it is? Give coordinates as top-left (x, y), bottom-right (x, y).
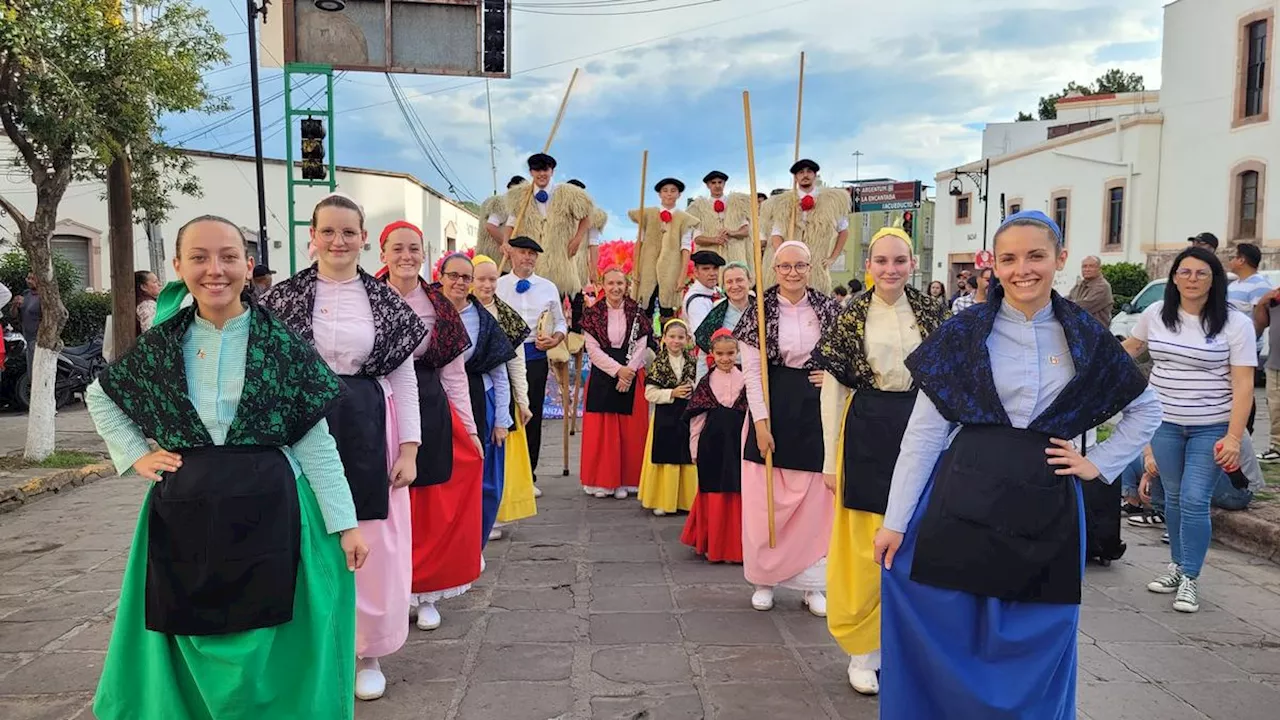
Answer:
top-left (640, 318), bottom-right (698, 516)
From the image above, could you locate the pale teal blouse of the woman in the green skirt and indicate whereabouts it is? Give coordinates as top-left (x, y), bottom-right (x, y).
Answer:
top-left (84, 311), bottom-right (356, 533)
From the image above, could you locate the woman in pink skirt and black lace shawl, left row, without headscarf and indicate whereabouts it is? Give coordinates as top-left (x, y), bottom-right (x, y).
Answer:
top-left (262, 193), bottom-right (426, 700)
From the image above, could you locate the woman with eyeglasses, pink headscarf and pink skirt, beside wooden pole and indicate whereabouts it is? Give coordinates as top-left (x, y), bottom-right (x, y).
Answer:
top-left (733, 241), bottom-right (840, 618)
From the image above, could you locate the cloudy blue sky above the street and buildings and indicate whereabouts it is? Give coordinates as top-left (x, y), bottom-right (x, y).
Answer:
top-left (165, 0), bottom-right (1165, 238)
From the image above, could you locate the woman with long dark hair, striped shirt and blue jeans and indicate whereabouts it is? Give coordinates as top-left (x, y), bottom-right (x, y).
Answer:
top-left (1124, 246), bottom-right (1258, 612)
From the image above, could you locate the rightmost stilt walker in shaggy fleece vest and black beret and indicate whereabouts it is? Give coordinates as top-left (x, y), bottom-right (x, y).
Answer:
top-left (764, 159), bottom-right (852, 293)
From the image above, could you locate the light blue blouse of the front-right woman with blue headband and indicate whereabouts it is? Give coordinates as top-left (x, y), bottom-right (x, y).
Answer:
top-left (884, 302), bottom-right (1161, 533)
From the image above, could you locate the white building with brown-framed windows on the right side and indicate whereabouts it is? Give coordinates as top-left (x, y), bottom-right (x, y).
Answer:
top-left (934, 0), bottom-right (1280, 292)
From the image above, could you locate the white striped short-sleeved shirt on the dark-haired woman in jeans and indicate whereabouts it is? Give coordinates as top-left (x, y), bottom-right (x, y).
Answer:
top-left (1133, 301), bottom-right (1258, 425)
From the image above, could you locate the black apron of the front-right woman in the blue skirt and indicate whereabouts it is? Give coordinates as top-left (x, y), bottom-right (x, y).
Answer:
top-left (911, 425), bottom-right (1082, 605)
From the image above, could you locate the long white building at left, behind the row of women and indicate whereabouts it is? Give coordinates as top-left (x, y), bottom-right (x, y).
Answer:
top-left (0, 146), bottom-right (479, 291)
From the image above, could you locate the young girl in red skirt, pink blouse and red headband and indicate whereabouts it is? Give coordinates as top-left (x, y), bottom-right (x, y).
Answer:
top-left (680, 328), bottom-right (746, 562)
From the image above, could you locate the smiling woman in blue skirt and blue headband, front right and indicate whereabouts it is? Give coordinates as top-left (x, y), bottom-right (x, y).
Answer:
top-left (876, 211), bottom-right (1160, 720)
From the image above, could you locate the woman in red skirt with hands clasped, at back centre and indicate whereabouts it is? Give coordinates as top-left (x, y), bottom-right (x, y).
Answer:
top-left (579, 268), bottom-right (653, 500)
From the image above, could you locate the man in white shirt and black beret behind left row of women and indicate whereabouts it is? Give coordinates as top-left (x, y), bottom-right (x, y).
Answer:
top-left (498, 236), bottom-right (568, 486)
